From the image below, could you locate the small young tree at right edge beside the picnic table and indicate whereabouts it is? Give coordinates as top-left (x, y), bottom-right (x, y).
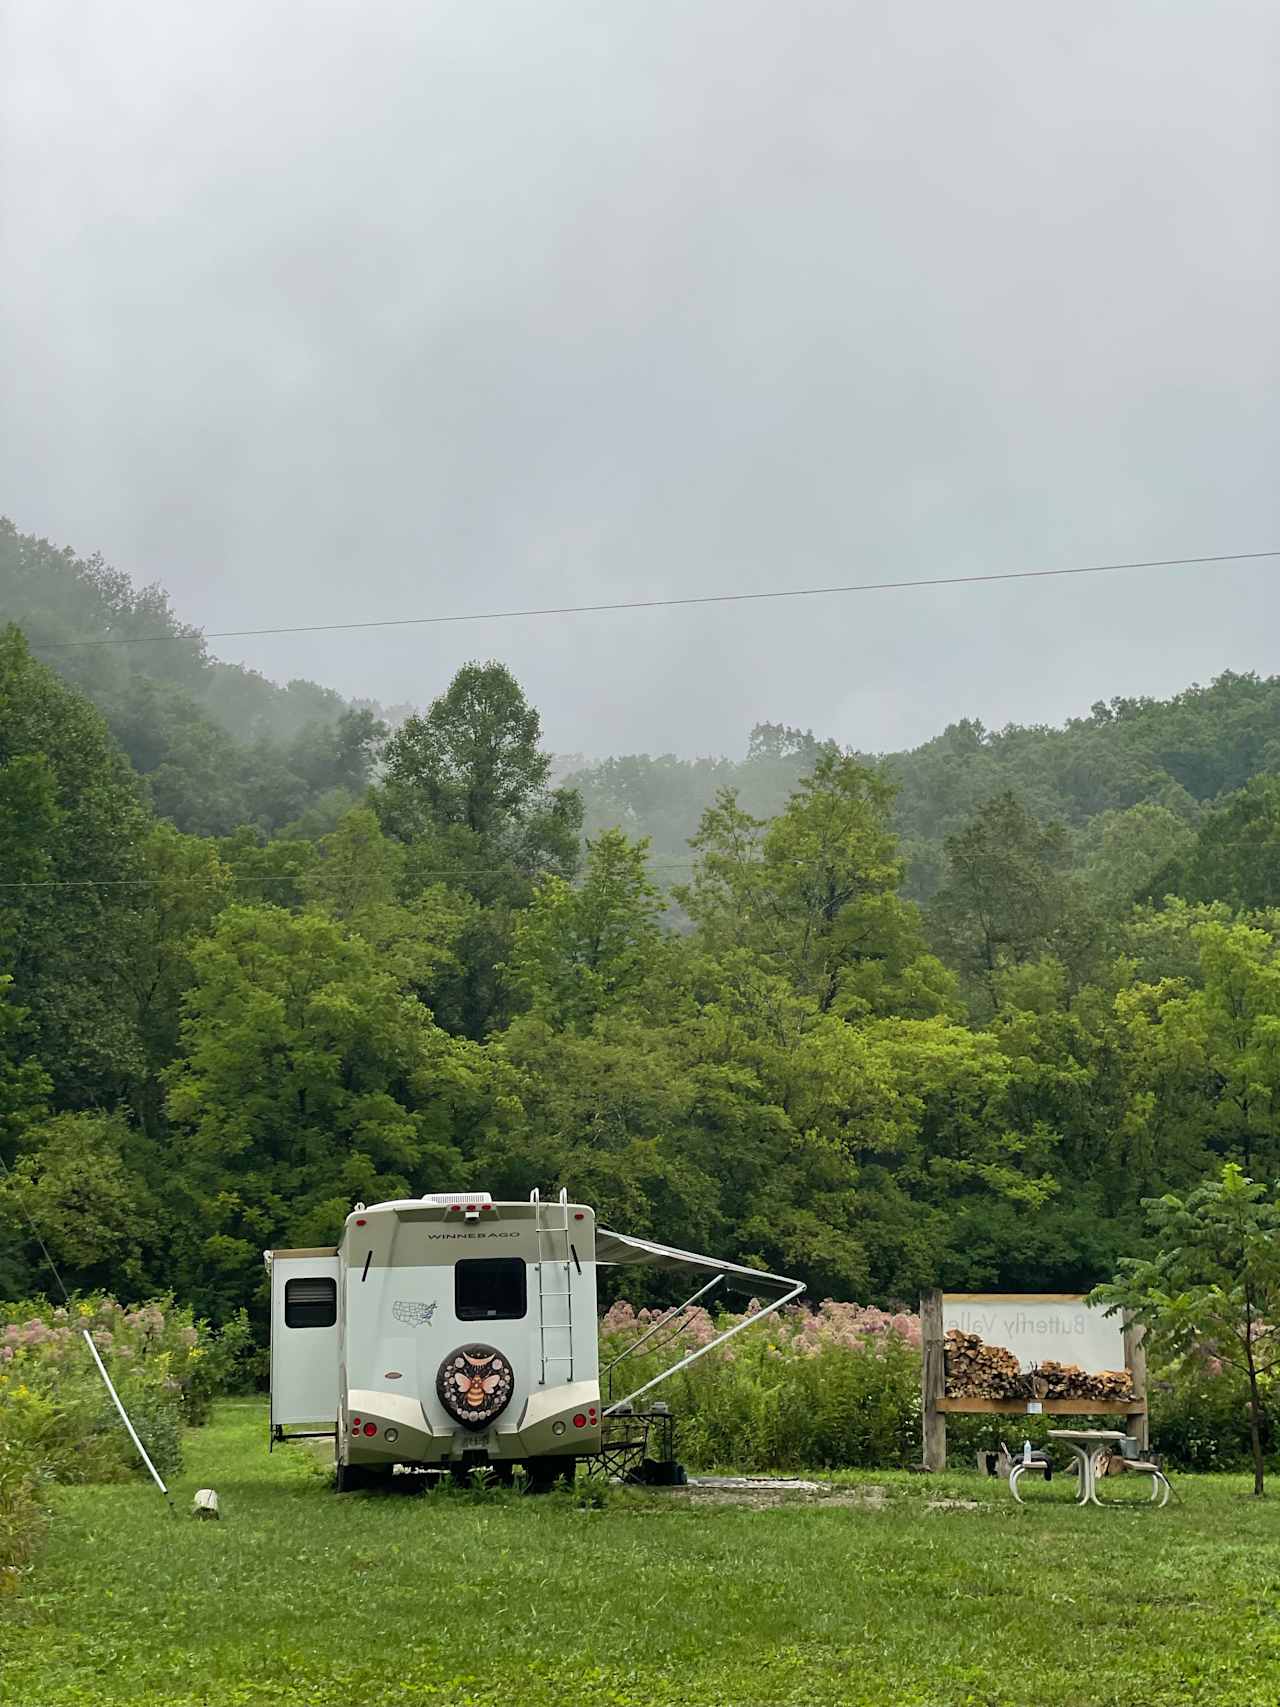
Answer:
top-left (1091, 1162), bottom-right (1280, 1497)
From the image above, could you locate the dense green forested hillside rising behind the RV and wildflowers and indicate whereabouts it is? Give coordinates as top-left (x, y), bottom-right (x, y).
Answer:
top-left (0, 531), bottom-right (1280, 1320)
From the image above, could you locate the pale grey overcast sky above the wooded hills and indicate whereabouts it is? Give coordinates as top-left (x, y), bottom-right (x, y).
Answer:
top-left (0, 0), bottom-right (1280, 754)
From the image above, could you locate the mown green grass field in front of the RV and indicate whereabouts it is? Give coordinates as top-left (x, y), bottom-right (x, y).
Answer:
top-left (0, 1401), bottom-right (1280, 1707)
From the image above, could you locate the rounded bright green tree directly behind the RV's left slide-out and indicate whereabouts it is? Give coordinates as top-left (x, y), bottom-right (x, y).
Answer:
top-left (167, 906), bottom-right (509, 1318)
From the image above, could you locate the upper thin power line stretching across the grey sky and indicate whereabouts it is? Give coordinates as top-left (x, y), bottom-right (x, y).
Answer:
top-left (32, 546), bottom-right (1280, 650)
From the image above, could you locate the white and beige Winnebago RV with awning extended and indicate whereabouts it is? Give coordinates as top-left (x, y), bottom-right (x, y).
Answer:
top-left (265, 1191), bottom-right (804, 1492)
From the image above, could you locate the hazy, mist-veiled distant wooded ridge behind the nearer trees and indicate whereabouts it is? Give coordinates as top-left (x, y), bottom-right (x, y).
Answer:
top-left (0, 519), bottom-right (1280, 898)
